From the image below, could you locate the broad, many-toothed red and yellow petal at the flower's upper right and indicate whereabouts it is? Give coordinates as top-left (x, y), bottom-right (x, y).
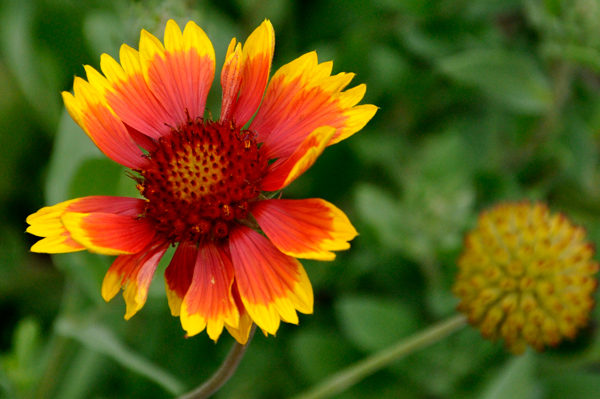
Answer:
top-left (250, 52), bottom-right (377, 158)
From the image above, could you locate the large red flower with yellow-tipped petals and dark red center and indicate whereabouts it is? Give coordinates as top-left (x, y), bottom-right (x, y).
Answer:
top-left (27, 20), bottom-right (377, 344)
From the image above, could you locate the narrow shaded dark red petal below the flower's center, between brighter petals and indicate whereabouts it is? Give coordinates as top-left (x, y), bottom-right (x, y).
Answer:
top-left (165, 241), bottom-right (198, 316)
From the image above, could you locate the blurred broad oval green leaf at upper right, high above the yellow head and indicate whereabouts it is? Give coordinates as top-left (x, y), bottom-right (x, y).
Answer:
top-left (438, 49), bottom-right (552, 114)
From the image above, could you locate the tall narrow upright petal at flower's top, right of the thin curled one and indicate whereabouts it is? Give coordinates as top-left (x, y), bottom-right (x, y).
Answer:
top-left (232, 20), bottom-right (275, 126)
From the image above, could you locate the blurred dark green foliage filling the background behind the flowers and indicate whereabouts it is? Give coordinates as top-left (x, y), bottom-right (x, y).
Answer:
top-left (0, 0), bottom-right (600, 399)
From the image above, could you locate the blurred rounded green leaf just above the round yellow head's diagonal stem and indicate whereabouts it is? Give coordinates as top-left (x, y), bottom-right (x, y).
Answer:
top-left (335, 297), bottom-right (418, 352)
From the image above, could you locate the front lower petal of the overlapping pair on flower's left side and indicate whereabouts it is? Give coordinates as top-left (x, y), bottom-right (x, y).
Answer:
top-left (60, 212), bottom-right (156, 255)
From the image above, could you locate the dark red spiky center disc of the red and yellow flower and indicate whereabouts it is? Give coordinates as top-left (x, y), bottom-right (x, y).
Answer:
top-left (137, 119), bottom-right (267, 243)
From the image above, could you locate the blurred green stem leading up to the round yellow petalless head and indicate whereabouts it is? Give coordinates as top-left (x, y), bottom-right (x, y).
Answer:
top-left (294, 315), bottom-right (467, 399)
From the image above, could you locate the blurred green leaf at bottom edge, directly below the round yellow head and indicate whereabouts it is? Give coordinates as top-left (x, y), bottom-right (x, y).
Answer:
top-left (480, 352), bottom-right (538, 399)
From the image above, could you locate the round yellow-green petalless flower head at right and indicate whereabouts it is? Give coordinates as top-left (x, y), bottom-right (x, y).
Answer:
top-left (454, 202), bottom-right (598, 354)
